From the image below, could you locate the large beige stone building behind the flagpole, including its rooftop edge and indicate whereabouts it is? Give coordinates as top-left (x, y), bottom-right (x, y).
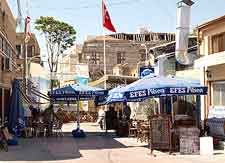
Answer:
top-left (80, 32), bottom-right (175, 80)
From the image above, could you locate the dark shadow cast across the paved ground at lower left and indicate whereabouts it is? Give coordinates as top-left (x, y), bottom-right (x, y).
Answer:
top-left (0, 129), bottom-right (148, 161)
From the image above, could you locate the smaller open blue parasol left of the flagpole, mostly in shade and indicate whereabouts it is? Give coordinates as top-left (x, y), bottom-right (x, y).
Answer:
top-left (48, 84), bottom-right (108, 101)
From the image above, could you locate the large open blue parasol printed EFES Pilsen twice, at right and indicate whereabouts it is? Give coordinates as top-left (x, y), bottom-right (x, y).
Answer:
top-left (124, 75), bottom-right (207, 101)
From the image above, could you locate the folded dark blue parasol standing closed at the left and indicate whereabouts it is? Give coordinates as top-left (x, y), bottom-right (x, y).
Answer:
top-left (8, 79), bottom-right (25, 135)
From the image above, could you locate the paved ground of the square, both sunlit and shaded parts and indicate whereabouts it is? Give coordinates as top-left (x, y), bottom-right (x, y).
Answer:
top-left (0, 123), bottom-right (225, 163)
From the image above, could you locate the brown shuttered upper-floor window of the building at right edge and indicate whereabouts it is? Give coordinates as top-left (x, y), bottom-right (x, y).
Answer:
top-left (212, 32), bottom-right (225, 53)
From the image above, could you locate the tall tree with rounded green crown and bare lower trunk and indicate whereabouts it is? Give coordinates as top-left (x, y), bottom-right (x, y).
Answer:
top-left (35, 16), bottom-right (76, 90)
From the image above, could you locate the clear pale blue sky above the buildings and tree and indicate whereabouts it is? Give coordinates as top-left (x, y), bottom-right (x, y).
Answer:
top-left (8, 0), bottom-right (225, 58)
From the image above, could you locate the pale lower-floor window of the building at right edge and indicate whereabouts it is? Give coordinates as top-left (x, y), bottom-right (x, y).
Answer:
top-left (212, 81), bottom-right (225, 106)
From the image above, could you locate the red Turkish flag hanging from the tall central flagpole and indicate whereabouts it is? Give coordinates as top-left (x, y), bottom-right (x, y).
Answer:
top-left (102, 0), bottom-right (116, 32)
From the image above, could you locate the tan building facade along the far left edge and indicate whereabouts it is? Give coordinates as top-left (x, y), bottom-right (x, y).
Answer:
top-left (0, 0), bottom-right (17, 120)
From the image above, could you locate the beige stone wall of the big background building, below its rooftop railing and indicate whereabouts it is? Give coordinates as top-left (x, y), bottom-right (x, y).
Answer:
top-left (82, 36), bottom-right (173, 80)
